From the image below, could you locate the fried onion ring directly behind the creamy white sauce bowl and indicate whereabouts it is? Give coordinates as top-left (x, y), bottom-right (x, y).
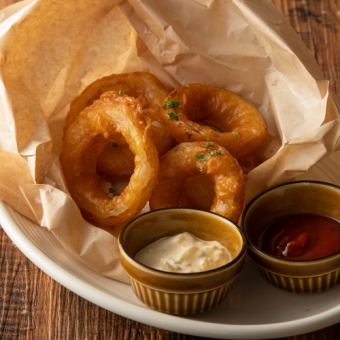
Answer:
top-left (150, 142), bottom-right (245, 222)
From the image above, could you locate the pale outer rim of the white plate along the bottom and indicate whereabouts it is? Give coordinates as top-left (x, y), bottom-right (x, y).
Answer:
top-left (0, 202), bottom-right (340, 339)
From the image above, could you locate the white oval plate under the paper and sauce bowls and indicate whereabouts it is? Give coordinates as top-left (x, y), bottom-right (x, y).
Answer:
top-left (0, 153), bottom-right (340, 339)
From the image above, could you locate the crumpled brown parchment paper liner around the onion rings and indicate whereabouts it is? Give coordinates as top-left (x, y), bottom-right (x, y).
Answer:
top-left (0, 0), bottom-right (340, 282)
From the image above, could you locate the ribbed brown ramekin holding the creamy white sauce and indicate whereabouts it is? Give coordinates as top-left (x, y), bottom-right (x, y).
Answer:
top-left (118, 208), bottom-right (246, 315)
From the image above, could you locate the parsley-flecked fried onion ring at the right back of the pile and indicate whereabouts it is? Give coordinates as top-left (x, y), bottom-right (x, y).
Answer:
top-left (163, 84), bottom-right (267, 159)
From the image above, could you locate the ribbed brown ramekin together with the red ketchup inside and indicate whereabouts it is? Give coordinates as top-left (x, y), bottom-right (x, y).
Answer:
top-left (242, 181), bottom-right (340, 292)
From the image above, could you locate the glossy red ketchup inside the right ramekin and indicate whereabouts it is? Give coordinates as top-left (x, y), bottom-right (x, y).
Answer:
top-left (259, 214), bottom-right (340, 260)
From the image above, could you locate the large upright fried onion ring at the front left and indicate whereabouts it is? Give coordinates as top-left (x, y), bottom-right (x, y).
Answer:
top-left (61, 92), bottom-right (158, 234)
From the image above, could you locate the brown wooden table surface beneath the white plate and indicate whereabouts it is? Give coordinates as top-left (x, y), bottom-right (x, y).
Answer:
top-left (0, 0), bottom-right (340, 340)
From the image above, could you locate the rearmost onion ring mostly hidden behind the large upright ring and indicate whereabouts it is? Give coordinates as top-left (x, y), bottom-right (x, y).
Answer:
top-left (65, 72), bottom-right (173, 155)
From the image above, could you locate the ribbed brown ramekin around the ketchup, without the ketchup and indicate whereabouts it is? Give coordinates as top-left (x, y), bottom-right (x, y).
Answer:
top-left (242, 181), bottom-right (340, 292)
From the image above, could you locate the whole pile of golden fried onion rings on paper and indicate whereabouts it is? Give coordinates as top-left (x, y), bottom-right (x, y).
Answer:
top-left (61, 72), bottom-right (267, 234)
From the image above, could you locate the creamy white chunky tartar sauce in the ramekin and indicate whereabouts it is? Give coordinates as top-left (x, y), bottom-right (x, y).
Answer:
top-left (135, 232), bottom-right (232, 273)
